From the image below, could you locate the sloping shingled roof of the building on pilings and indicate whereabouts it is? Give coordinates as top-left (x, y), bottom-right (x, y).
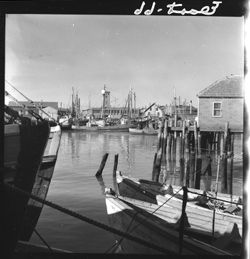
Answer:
top-left (198, 75), bottom-right (243, 98)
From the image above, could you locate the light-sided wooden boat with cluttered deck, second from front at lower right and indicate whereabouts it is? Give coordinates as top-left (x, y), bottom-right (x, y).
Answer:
top-left (114, 172), bottom-right (242, 249)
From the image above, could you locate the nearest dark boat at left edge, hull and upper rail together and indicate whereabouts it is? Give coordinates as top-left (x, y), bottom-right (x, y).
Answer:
top-left (2, 105), bottom-right (50, 255)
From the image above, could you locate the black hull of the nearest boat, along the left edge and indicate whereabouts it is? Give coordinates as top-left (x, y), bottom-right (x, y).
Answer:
top-left (3, 122), bottom-right (49, 254)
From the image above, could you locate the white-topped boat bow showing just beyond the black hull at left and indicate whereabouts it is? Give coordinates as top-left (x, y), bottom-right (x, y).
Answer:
top-left (19, 122), bottom-right (61, 241)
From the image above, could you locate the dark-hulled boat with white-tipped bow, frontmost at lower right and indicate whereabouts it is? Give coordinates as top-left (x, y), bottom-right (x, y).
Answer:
top-left (105, 189), bottom-right (232, 256)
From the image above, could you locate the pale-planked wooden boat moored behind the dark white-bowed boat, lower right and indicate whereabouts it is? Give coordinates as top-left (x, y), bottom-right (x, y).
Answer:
top-left (114, 172), bottom-right (242, 254)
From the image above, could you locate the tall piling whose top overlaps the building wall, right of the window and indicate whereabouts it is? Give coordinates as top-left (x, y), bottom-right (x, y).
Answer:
top-left (221, 122), bottom-right (229, 193)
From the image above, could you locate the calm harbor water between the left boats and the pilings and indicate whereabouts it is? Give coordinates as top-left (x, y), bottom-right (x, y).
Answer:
top-left (30, 131), bottom-right (243, 254)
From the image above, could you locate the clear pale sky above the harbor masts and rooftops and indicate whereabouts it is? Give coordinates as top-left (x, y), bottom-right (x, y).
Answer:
top-left (5, 14), bottom-right (244, 109)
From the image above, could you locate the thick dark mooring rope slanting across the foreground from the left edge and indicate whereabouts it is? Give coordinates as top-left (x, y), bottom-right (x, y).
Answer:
top-left (2, 183), bottom-right (176, 255)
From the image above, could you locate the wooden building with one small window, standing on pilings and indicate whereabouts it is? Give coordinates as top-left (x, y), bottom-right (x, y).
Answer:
top-left (198, 75), bottom-right (244, 132)
